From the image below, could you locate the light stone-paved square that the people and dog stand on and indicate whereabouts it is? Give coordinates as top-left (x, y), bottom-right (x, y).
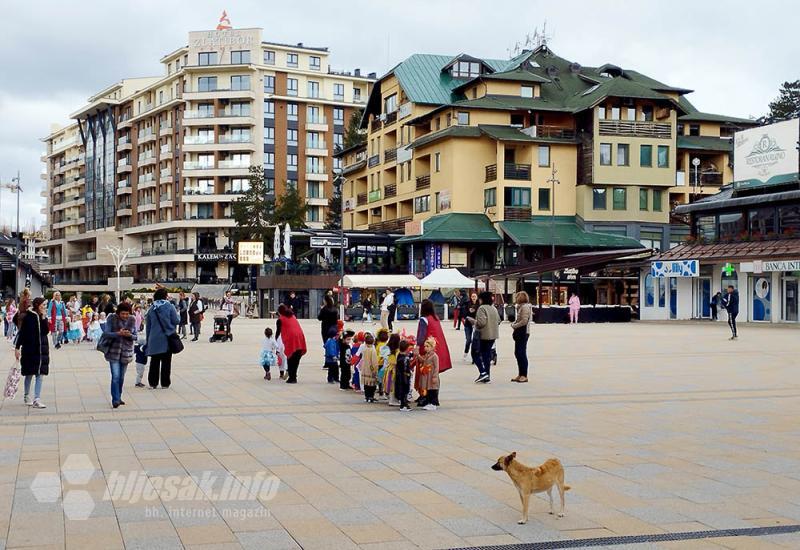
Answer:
top-left (0, 320), bottom-right (800, 550)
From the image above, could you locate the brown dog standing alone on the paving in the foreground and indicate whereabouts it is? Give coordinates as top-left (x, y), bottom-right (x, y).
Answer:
top-left (492, 451), bottom-right (570, 524)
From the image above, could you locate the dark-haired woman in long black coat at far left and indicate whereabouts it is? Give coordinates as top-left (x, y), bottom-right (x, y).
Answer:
top-left (14, 297), bottom-right (50, 409)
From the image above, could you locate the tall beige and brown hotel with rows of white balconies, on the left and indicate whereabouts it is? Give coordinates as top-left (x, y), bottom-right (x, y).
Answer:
top-left (42, 24), bottom-right (374, 290)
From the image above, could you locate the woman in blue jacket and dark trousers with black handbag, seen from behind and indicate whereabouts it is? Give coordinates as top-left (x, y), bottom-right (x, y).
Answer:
top-left (145, 288), bottom-right (183, 390)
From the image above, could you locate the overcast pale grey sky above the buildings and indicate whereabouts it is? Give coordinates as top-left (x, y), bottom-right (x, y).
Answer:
top-left (0, 0), bottom-right (800, 229)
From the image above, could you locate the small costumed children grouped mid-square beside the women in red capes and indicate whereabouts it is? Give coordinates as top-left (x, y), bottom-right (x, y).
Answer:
top-left (259, 321), bottom-right (439, 412)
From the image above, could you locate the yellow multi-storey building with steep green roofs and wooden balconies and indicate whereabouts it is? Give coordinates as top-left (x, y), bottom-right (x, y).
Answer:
top-left (342, 46), bottom-right (754, 278)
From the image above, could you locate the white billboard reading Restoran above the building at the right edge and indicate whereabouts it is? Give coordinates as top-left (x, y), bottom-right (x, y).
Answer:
top-left (733, 119), bottom-right (798, 183)
